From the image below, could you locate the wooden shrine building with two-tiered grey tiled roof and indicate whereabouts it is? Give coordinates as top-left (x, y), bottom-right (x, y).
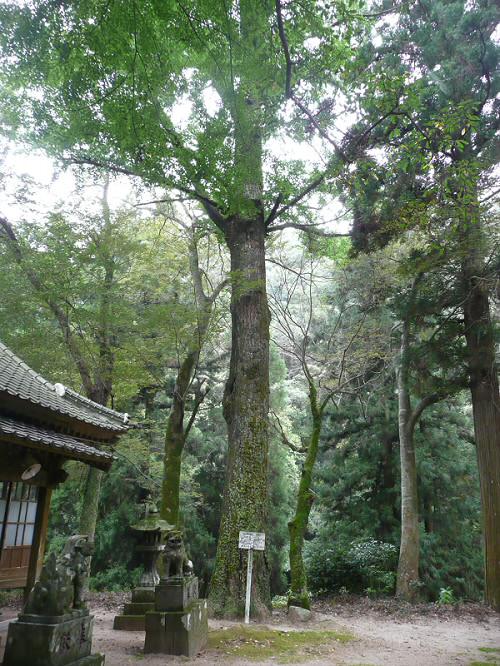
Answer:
top-left (0, 342), bottom-right (130, 590)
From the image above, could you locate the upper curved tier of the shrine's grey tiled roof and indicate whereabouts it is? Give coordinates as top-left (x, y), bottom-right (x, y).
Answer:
top-left (0, 342), bottom-right (129, 433)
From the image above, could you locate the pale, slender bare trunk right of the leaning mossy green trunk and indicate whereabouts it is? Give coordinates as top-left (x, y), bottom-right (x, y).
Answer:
top-left (396, 321), bottom-right (420, 601)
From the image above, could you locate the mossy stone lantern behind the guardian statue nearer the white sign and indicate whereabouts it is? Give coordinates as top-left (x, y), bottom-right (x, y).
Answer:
top-left (113, 504), bottom-right (174, 631)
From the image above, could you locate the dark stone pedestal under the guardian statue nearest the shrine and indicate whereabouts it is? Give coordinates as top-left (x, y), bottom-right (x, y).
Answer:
top-left (3, 610), bottom-right (104, 666)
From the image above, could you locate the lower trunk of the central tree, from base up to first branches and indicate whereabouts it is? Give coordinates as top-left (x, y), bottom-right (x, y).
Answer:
top-left (209, 216), bottom-right (270, 616)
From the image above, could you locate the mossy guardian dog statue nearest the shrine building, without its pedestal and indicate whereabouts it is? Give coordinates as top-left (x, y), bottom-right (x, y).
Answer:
top-left (24, 534), bottom-right (93, 615)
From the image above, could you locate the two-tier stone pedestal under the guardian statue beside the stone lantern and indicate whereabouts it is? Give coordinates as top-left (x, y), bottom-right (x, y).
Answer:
top-left (144, 576), bottom-right (208, 657)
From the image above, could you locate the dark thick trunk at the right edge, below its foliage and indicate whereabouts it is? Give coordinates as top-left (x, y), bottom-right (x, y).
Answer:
top-left (462, 204), bottom-right (500, 611)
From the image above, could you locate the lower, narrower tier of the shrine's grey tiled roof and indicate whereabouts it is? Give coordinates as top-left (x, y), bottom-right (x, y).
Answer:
top-left (0, 416), bottom-right (114, 469)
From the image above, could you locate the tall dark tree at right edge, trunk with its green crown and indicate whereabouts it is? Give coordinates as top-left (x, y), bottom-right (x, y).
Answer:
top-left (344, 0), bottom-right (500, 608)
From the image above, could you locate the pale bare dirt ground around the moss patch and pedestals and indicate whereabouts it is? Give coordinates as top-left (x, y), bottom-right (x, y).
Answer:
top-left (1, 594), bottom-right (500, 666)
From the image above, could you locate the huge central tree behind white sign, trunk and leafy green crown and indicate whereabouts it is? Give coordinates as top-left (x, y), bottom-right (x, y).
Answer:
top-left (0, 0), bottom-right (358, 614)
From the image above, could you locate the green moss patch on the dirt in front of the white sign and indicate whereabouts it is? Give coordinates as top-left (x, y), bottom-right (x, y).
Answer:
top-left (208, 625), bottom-right (354, 664)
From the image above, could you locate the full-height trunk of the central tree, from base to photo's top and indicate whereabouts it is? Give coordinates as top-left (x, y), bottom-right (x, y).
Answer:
top-left (209, 0), bottom-right (273, 617)
